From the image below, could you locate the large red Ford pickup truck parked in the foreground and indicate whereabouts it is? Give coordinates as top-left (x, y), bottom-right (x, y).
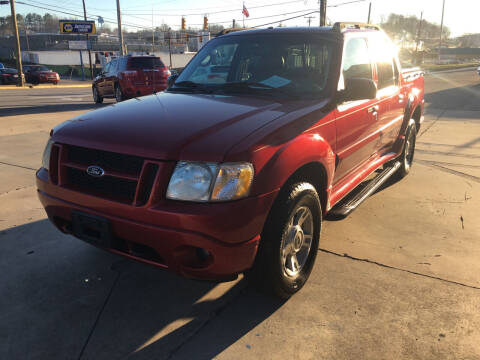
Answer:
top-left (37, 23), bottom-right (424, 298)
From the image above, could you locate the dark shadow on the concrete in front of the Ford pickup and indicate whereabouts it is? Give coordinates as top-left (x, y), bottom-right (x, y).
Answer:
top-left (0, 220), bottom-right (284, 359)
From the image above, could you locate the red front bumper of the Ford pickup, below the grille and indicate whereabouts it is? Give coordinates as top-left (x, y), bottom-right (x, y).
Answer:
top-left (37, 169), bottom-right (276, 280)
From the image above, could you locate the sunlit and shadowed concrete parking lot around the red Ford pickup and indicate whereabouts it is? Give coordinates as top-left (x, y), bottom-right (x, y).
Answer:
top-left (0, 69), bottom-right (480, 359)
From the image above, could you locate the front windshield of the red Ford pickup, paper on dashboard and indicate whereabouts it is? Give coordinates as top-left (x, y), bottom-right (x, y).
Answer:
top-left (170, 34), bottom-right (332, 96)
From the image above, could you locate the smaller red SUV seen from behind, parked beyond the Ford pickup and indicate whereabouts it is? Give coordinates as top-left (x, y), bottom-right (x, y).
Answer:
top-left (92, 55), bottom-right (170, 103)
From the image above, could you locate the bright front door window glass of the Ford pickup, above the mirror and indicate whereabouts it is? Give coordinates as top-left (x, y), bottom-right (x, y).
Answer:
top-left (343, 38), bottom-right (373, 80)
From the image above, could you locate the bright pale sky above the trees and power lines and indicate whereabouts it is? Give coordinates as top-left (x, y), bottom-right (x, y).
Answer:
top-left (0, 0), bottom-right (480, 36)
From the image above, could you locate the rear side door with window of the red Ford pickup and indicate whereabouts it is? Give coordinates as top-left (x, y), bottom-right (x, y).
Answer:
top-left (368, 32), bottom-right (405, 152)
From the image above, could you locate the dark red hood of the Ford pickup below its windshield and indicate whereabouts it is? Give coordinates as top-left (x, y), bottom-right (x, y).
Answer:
top-left (52, 92), bottom-right (310, 162)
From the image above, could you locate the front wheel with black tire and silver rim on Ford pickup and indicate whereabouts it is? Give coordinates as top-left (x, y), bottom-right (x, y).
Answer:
top-left (245, 182), bottom-right (322, 299)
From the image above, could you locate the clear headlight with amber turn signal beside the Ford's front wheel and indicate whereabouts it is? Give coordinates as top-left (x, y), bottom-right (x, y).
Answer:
top-left (167, 161), bottom-right (254, 202)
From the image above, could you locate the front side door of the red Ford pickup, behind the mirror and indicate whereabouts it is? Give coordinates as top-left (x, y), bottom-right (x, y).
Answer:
top-left (334, 36), bottom-right (378, 182)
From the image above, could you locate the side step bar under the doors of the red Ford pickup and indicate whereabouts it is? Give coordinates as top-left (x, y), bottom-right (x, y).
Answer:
top-left (327, 161), bottom-right (401, 218)
